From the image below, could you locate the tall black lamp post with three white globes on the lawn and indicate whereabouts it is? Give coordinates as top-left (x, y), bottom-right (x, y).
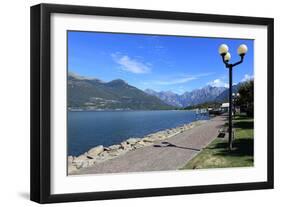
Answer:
top-left (219, 44), bottom-right (248, 150)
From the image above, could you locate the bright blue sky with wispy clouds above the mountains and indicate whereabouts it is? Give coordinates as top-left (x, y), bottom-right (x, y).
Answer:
top-left (68, 31), bottom-right (254, 94)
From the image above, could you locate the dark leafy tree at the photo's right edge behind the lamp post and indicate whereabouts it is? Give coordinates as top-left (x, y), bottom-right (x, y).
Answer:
top-left (238, 80), bottom-right (254, 117)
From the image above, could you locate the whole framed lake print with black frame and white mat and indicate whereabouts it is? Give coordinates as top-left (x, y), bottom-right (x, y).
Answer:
top-left (31, 4), bottom-right (274, 203)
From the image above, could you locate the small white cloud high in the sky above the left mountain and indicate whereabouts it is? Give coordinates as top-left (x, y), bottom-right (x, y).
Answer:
top-left (111, 53), bottom-right (151, 74)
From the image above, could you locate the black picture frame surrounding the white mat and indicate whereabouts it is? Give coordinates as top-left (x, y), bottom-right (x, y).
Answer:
top-left (30, 4), bottom-right (274, 203)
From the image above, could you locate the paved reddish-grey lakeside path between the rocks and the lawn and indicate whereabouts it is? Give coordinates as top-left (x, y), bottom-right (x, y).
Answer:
top-left (71, 116), bottom-right (225, 174)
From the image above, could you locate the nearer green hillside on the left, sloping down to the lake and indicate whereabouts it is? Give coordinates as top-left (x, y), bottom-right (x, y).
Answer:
top-left (68, 74), bottom-right (174, 110)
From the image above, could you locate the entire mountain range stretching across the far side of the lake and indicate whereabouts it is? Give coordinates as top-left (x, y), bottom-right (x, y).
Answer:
top-left (68, 73), bottom-right (241, 110)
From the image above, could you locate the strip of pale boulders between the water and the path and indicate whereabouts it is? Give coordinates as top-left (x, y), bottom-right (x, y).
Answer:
top-left (67, 120), bottom-right (206, 175)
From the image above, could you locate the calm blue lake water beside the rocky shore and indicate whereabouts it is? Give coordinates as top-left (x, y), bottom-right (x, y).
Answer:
top-left (68, 111), bottom-right (209, 156)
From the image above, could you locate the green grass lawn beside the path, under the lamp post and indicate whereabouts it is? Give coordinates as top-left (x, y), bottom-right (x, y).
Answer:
top-left (181, 116), bottom-right (254, 169)
